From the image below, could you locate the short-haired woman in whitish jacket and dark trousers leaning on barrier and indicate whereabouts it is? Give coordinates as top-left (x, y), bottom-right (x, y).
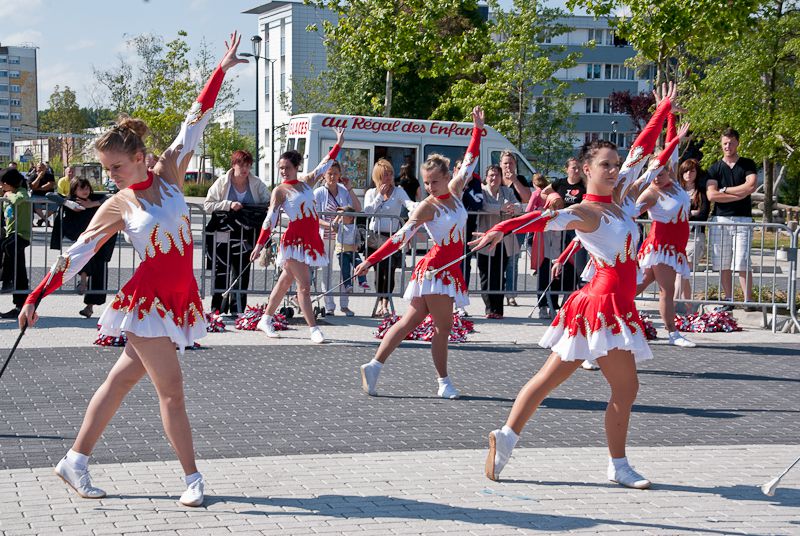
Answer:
top-left (203, 150), bottom-right (269, 314)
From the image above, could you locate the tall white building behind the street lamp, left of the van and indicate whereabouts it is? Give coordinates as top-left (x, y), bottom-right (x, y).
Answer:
top-left (244, 0), bottom-right (336, 184)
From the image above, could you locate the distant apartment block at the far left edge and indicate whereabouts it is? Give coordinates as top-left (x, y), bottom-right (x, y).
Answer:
top-left (0, 45), bottom-right (39, 165)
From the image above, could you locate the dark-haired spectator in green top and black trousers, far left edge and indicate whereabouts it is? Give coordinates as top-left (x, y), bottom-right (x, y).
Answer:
top-left (0, 168), bottom-right (31, 318)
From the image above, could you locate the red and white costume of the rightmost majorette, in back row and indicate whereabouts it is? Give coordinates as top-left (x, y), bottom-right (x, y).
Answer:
top-left (638, 114), bottom-right (692, 277)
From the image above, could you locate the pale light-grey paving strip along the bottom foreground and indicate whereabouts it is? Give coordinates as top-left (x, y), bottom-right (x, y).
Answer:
top-left (0, 445), bottom-right (800, 536)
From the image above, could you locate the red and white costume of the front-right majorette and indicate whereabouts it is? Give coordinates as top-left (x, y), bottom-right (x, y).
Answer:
top-left (490, 99), bottom-right (677, 361)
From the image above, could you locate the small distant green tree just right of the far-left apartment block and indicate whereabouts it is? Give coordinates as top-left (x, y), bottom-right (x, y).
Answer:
top-left (39, 86), bottom-right (86, 162)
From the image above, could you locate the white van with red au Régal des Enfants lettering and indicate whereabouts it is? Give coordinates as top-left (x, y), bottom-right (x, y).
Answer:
top-left (285, 114), bottom-right (534, 192)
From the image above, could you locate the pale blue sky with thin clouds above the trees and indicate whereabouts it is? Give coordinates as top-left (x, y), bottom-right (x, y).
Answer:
top-left (0, 0), bottom-right (588, 110)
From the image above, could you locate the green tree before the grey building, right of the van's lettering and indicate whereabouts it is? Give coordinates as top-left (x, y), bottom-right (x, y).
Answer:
top-left (434, 0), bottom-right (580, 173)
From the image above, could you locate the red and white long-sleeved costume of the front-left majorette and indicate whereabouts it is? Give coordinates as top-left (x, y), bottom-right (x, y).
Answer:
top-left (26, 63), bottom-right (225, 353)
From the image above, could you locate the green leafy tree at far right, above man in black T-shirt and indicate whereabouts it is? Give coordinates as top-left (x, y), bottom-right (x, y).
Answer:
top-left (686, 0), bottom-right (800, 221)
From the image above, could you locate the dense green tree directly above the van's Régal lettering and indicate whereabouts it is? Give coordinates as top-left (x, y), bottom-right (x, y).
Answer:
top-left (309, 0), bottom-right (488, 117)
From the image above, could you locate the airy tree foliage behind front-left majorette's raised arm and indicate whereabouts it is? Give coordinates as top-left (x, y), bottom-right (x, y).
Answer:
top-left (94, 31), bottom-right (236, 152)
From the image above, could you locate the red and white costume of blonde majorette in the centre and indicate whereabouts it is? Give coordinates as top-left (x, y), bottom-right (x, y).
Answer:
top-left (367, 123), bottom-right (483, 307)
